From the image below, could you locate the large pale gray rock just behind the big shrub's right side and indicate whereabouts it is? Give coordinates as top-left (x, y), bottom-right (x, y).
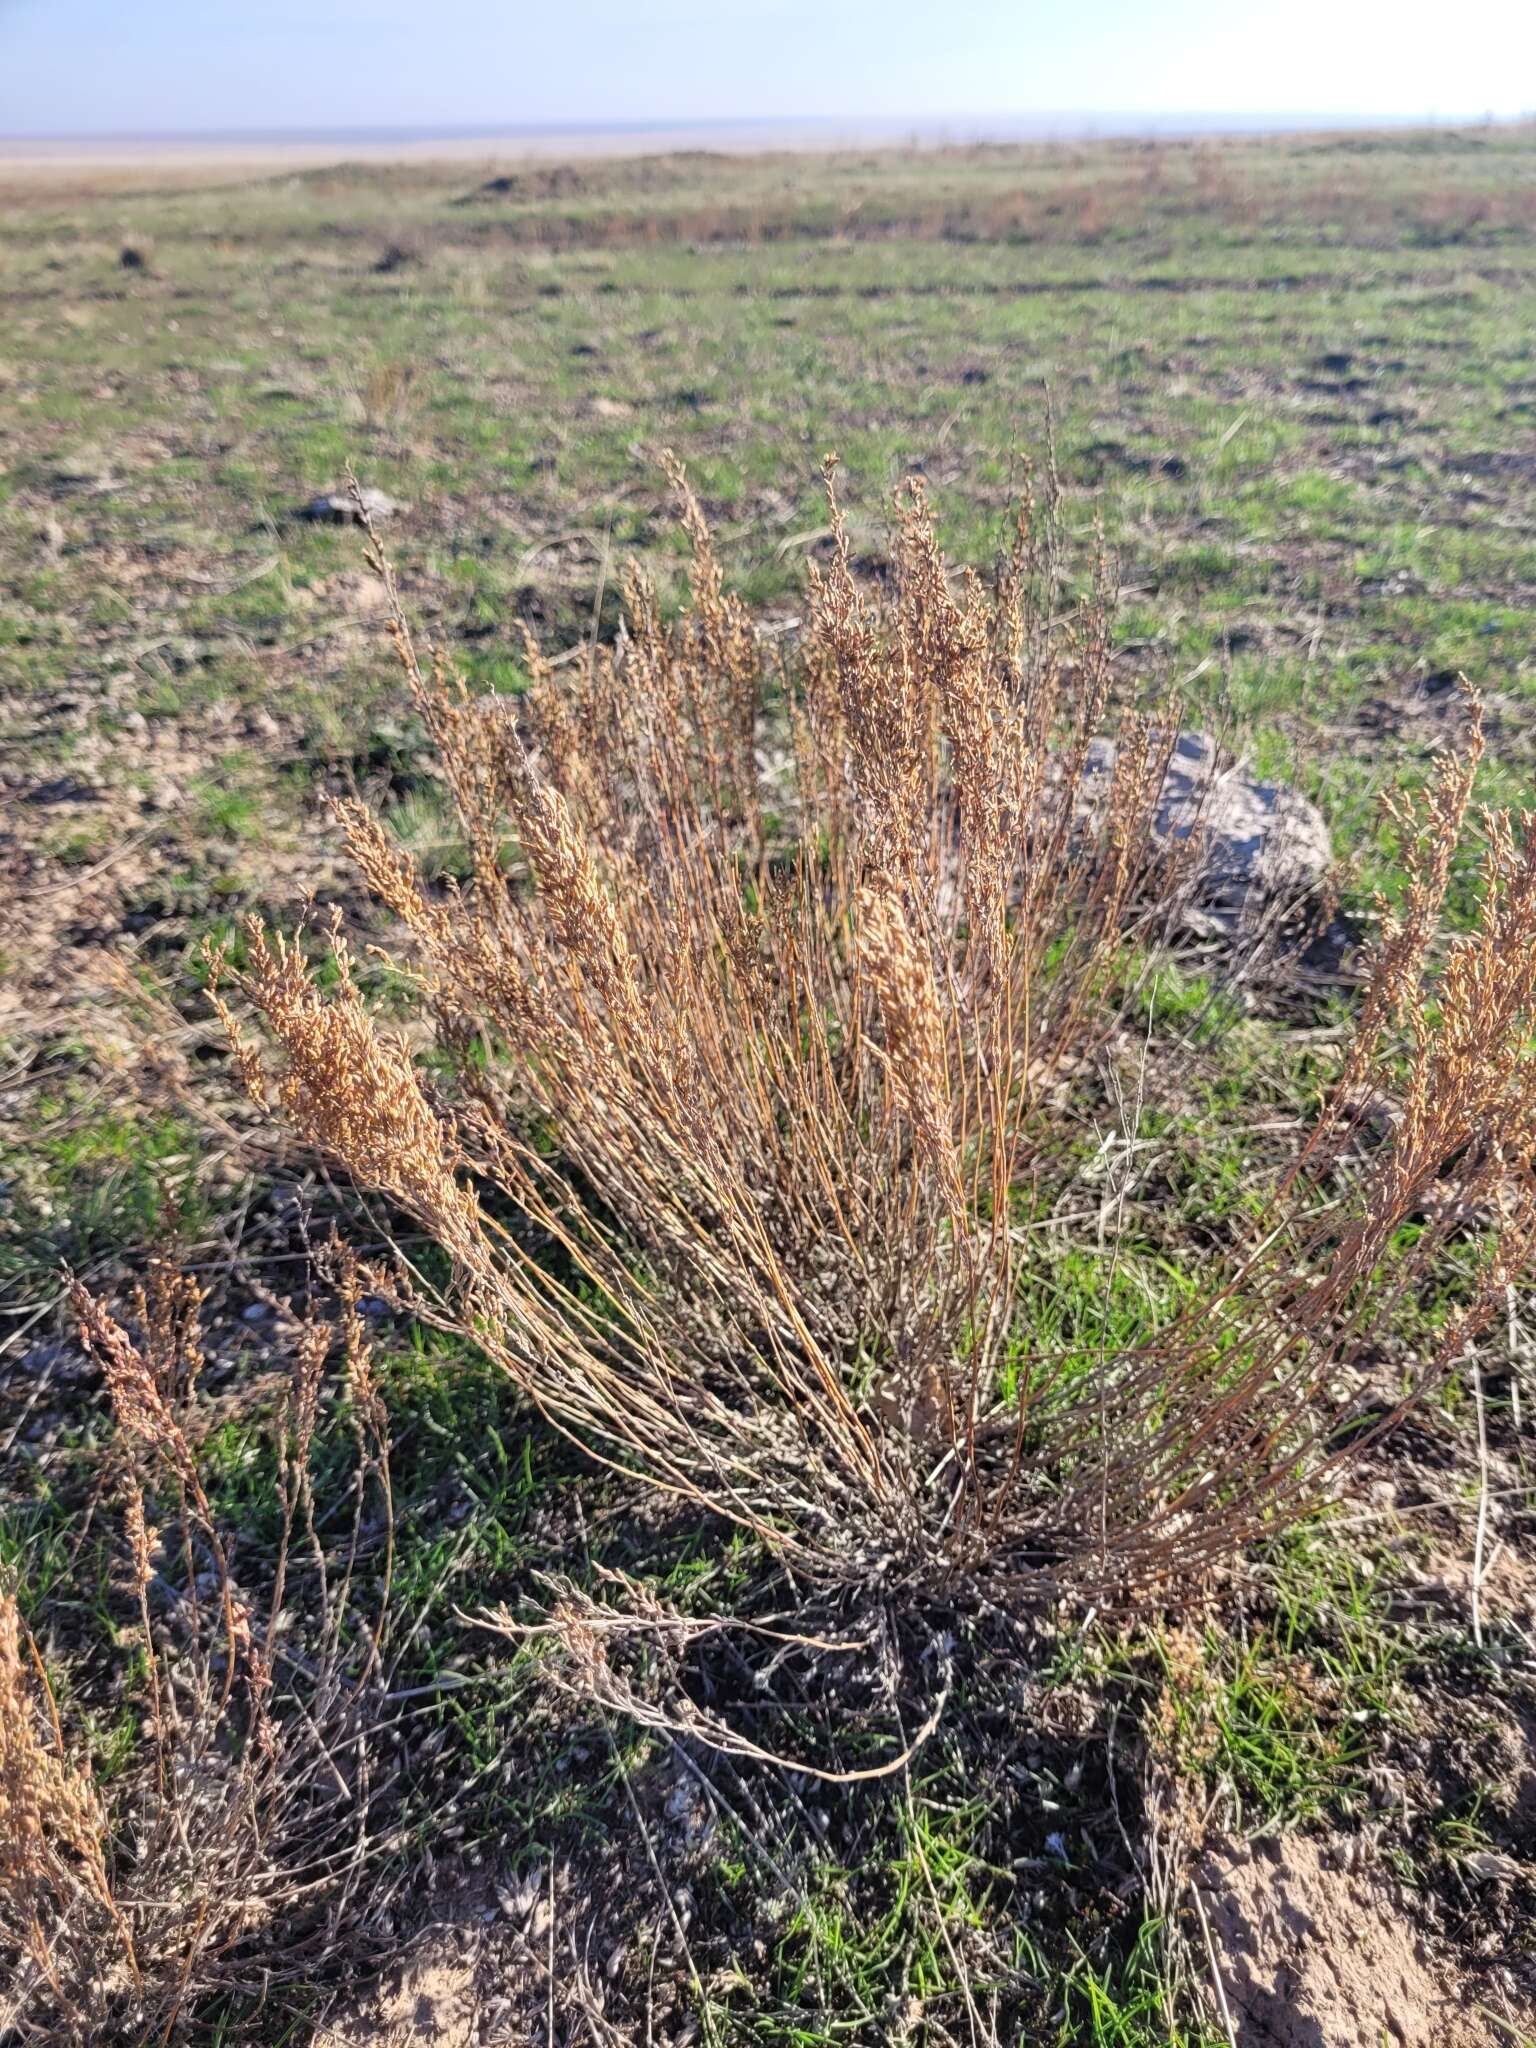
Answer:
top-left (1077, 733), bottom-right (1333, 922)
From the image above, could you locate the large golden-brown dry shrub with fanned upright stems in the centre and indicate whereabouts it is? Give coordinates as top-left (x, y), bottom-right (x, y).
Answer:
top-left (217, 469), bottom-right (1536, 1602)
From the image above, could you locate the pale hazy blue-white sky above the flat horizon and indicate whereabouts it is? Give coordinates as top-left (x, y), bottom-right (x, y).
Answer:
top-left (0, 0), bottom-right (1536, 135)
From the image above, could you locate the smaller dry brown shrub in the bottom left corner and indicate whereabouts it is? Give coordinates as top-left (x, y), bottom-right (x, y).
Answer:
top-left (0, 1266), bottom-right (391, 2042)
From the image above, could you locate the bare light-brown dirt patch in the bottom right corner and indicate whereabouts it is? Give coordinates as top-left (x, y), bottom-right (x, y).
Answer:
top-left (1200, 1835), bottom-right (1536, 2048)
